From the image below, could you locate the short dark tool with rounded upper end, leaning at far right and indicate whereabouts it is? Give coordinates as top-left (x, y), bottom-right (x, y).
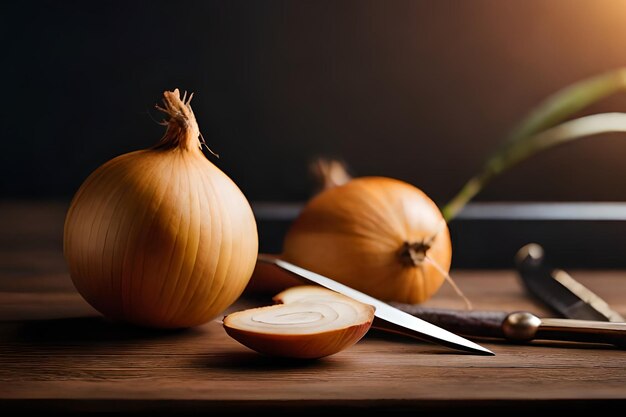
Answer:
top-left (515, 243), bottom-right (624, 322)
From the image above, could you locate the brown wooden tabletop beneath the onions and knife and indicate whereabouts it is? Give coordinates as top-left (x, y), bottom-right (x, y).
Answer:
top-left (0, 203), bottom-right (626, 415)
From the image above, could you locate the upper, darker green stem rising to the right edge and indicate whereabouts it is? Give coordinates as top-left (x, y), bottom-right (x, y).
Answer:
top-left (442, 68), bottom-right (626, 221)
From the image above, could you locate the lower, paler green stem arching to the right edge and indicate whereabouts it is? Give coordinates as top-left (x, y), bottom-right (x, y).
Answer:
top-left (442, 113), bottom-right (626, 221)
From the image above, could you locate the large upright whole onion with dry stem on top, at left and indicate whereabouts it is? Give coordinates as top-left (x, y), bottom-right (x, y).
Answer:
top-left (64, 90), bottom-right (258, 328)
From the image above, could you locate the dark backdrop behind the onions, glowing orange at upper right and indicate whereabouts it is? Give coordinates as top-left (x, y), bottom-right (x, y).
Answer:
top-left (0, 0), bottom-right (626, 204)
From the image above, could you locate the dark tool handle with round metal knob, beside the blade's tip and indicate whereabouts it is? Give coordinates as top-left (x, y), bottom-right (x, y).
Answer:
top-left (392, 303), bottom-right (626, 348)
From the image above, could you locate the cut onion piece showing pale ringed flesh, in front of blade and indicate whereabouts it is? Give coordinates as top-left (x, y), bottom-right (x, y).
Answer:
top-left (223, 286), bottom-right (375, 359)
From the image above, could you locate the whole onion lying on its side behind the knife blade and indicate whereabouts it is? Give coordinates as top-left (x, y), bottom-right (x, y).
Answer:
top-left (281, 177), bottom-right (452, 304)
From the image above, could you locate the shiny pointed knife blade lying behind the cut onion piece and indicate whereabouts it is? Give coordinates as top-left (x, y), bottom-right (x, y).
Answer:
top-left (258, 255), bottom-right (494, 355)
